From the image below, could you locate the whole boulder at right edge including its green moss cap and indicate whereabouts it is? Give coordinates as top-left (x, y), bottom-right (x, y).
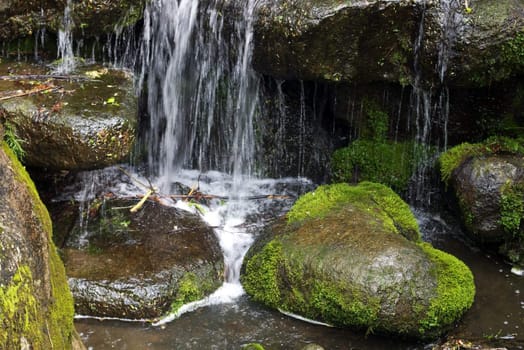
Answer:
top-left (440, 138), bottom-right (524, 267)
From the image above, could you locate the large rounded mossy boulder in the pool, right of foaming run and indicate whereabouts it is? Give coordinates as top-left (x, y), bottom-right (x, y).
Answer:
top-left (242, 182), bottom-right (475, 338)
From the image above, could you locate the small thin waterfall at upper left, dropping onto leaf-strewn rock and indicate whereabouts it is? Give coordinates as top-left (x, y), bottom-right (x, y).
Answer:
top-left (56, 0), bottom-right (75, 74)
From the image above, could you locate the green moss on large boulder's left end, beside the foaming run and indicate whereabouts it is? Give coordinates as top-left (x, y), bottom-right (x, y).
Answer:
top-left (242, 241), bottom-right (284, 308)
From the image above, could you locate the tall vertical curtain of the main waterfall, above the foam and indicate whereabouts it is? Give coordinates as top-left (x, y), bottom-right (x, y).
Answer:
top-left (141, 0), bottom-right (258, 191)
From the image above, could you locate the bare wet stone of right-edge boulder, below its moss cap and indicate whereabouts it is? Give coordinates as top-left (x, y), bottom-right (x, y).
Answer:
top-left (451, 155), bottom-right (524, 266)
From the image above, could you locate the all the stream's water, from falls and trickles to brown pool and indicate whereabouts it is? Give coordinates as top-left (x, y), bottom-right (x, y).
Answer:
top-left (59, 0), bottom-right (524, 349)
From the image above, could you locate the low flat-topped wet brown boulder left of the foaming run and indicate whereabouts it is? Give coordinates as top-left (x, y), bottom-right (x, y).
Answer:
top-left (51, 200), bottom-right (224, 319)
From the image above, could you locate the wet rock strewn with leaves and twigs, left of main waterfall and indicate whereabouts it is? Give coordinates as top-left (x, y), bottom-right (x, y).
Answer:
top-left (0, 62), bottom-right (138, 170)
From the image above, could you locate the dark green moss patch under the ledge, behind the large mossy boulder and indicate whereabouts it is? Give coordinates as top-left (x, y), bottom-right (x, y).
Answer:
top-left (331, 140), bottom-right (430, 192)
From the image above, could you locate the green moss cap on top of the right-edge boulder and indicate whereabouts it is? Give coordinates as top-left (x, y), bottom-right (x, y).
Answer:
top-left (439, 136), bottom-right (524, 185)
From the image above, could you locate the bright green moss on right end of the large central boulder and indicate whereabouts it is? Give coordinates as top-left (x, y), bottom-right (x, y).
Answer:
top-left (420, 243), bottom-right (475, 335)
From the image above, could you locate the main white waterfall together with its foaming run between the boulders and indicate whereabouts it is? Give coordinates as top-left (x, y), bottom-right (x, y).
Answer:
top-left (135, 0), bottom-right (268, 324)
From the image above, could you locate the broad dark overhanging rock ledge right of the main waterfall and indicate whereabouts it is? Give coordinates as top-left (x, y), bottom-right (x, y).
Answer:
top-left (254, 0), bottom-right (524, 85)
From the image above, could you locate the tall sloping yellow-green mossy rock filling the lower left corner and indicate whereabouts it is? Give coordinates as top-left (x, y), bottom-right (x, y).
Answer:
top-left (0, 139), bottom-right (83, 349)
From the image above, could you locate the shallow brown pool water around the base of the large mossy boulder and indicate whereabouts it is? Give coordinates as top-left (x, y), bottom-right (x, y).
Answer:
top-left (67, 171), bottom-right (524, 350)
